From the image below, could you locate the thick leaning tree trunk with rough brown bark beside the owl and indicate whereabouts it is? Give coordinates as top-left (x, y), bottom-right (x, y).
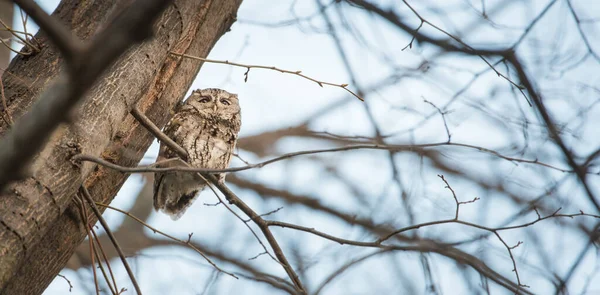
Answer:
top-left (0, 0), bottom-right (241, 294)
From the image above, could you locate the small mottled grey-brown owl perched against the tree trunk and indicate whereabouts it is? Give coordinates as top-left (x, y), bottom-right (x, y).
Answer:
top-left (154, 88), bottom-right (241, 220)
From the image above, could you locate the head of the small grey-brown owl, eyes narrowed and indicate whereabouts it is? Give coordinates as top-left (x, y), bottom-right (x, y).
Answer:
top-left (185, 88), bottom-right (240, 119)
